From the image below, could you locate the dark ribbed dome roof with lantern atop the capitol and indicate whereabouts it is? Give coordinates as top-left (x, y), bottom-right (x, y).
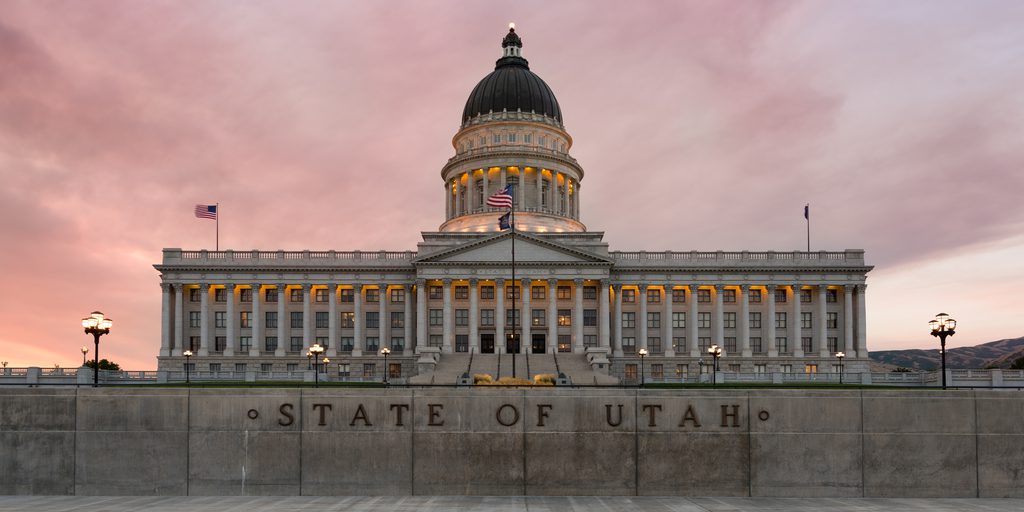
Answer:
top-left (462, 29), bottom-right (562, 123)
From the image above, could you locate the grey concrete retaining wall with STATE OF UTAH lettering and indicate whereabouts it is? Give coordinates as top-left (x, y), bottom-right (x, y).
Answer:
top-left (0, 387), bottom-right (1024, 498)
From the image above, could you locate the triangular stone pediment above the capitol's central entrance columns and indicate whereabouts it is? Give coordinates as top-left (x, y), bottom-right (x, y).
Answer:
top-left (416, 232), bottom-right (611, 264)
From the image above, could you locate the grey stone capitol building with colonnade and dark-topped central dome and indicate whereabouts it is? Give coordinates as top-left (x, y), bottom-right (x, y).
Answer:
top-left (155, 29), bottom-right (871, 384)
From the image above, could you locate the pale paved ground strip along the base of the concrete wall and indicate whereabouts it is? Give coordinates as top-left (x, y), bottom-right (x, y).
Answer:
top-left (0, 496), bottom-right (1024, 512)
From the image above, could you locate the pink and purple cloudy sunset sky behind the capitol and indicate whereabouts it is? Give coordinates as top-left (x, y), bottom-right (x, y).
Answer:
top-left (0, 0), bottom-right (1024, 370)
